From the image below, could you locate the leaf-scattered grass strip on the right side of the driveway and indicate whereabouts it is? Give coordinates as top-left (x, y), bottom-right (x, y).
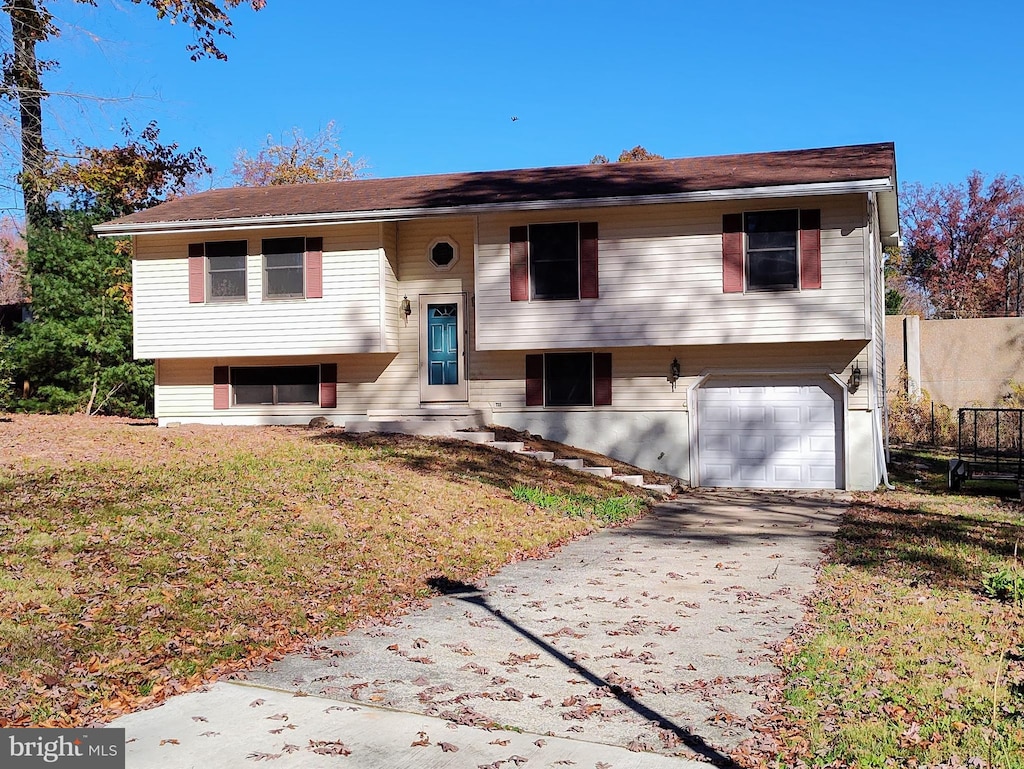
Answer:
top-left (737, 451), bottom-right (1024, 769)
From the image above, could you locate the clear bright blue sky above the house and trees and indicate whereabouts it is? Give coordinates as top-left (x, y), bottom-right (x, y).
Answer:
top-left (2, 0), bottom-right (1024, 217)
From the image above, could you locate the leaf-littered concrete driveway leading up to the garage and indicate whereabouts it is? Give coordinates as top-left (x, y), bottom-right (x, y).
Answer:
top-left (111, 492), bottom-right (845, 769)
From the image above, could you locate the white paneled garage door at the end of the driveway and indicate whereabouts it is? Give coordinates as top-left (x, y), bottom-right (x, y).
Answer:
top-left (697, 380), bottom-right (843, 488)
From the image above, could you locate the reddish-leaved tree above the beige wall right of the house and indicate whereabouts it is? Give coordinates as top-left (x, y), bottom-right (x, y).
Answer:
top-left (900, 171), bottom-right (1024, 318)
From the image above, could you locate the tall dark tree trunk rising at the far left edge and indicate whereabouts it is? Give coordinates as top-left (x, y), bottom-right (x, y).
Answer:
top-left (3, 0), bottom-right (52, 227)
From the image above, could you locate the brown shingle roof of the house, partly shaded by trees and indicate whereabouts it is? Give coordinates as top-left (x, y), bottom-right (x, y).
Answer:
top-left (100, 142), bottom-right (896, 230)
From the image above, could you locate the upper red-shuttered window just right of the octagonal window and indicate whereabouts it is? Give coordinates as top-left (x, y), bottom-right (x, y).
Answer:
top-left (509, 222), bottom-right (598, 301)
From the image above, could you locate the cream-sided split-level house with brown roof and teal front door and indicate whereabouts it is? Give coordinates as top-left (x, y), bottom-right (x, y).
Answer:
top-left (97, 143), bottom-right (898, 488)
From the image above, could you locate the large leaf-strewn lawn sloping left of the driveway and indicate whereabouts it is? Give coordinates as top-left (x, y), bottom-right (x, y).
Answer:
top-left (0, 416), bottom-right (648, 726)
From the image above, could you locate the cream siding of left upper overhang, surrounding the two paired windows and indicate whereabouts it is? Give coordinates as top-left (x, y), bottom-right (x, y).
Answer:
top-left (133, 224), bottom-right (386, 358)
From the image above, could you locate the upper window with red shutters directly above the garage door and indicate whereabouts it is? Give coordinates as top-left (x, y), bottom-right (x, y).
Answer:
top-left (722, 209), bottom-right (821, 293)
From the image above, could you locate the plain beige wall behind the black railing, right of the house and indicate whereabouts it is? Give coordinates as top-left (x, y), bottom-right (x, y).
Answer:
top-left (886, 315), bottom-right (1024, 409)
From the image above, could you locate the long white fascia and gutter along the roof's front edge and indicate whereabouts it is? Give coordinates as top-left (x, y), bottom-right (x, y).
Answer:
top-left (93, 177), bottom-right (894, 238)
